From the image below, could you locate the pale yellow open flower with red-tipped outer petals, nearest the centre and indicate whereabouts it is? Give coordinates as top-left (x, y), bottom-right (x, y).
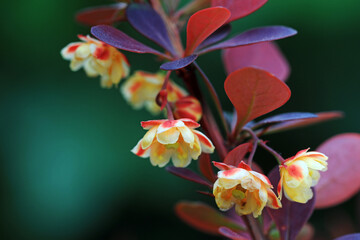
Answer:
top-left (131, 118), bottom-right (214, 167)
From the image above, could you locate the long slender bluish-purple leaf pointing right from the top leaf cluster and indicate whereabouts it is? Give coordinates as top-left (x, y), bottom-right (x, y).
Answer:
top-left (199, 26), bottom-right (297, 54)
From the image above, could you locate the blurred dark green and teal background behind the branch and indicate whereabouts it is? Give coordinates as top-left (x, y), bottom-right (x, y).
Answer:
top-left (0, 0), bottom-right (360, 240)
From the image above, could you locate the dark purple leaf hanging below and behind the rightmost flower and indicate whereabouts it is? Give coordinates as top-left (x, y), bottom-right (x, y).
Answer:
top-left (267, 167), bottom-right (316, 240)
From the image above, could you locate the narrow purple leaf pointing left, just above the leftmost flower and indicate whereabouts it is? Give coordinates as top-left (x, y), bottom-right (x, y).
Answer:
top-left (91, 25), bottom-right (169, 59)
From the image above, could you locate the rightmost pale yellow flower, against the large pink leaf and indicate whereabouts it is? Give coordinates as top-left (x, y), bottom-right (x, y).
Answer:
top-left (278, 149), bottom-right (328, 203)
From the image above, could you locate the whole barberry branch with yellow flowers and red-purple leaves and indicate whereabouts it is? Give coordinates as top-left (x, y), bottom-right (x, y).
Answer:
top-left (61, 0), bottom-right (360, 240)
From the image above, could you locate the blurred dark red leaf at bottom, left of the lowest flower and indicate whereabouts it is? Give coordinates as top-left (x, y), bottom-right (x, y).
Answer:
top-left (175, 202), bottom-right (244, 235)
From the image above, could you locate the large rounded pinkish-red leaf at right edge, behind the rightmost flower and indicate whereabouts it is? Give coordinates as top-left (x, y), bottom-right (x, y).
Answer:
top-left (315, 133), bottom-right (360, 208)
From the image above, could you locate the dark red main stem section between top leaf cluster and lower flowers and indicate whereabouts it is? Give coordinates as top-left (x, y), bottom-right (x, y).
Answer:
top-left (178, 66), bottom-right (227, 161)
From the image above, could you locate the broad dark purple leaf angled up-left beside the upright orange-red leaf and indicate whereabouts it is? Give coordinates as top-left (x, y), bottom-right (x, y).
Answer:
top-left (126, 4), bottom-right (175, 55)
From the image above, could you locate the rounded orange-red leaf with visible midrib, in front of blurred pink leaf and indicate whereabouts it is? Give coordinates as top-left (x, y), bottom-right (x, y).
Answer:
top-left (225, 68), bottom-right (291, 131)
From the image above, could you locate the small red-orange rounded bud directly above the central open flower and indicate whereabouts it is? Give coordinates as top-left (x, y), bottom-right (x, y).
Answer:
top-left (173, 96), bottom-right (202, 122)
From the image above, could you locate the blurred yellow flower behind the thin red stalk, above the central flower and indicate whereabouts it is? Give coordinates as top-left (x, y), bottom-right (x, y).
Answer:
top-left (121, 71), bottom-right (187, 114)
